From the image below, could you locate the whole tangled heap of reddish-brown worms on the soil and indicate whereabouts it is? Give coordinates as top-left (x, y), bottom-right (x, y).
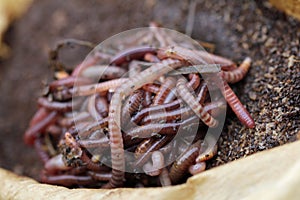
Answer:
top-left (24, 24), bottom-right (255, 188)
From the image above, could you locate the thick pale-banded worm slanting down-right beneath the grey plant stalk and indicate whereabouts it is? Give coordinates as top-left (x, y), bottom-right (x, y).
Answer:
top-left (176, 78), bottom-right (218, 127)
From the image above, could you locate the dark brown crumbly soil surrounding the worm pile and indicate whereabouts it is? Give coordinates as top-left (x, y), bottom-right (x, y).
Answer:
top-left (0, 0), bottom-right (300, 179)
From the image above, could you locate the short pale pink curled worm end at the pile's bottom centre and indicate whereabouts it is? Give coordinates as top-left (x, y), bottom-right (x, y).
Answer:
top-left (143, 151), bottom-right (164, 176)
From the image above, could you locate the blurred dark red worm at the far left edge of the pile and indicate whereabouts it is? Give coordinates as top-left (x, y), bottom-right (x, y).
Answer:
top-left (24, 111), bottom-right (58, 145)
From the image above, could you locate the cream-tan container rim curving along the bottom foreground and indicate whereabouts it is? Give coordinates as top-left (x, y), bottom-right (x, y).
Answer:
top-left (0, 141), bottom-right (300, 200)
